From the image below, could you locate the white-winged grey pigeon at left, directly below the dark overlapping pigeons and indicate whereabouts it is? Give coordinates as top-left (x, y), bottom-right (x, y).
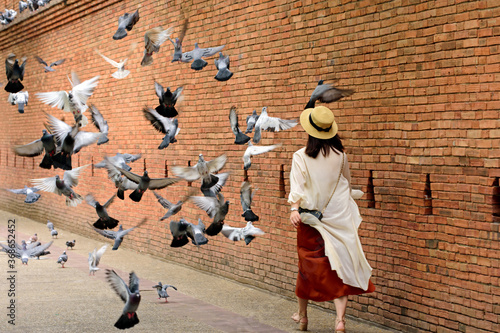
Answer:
top-left (31, 164), bottom-right (89, 207)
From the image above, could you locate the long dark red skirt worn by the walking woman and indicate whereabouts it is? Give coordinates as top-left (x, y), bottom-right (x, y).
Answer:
top-left (295, 223), bottom-right (375, 302)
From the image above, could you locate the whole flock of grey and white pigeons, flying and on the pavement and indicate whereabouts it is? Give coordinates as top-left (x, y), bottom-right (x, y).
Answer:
top-left (0, 0), bottom-right (353, 329)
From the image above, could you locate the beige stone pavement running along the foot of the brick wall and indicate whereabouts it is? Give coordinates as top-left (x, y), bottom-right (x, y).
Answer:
top-left (0, 211), bottom-right (396, 333)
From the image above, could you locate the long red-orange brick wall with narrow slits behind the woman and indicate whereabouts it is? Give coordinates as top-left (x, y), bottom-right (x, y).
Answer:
top-left (0, 0), bottom-right (500, 332)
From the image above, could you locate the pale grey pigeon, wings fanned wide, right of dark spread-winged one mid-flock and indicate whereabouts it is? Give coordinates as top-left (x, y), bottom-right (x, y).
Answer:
top-left (172, 154), bottom-right (227, 189)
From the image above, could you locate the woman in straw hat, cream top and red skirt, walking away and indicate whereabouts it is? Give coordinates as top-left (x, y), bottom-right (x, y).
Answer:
top-left (288, 106), bottom-right (375, 332)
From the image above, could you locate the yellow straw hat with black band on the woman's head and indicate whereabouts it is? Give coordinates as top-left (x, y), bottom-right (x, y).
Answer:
top-left (300, 105), bottom-right (338, 139)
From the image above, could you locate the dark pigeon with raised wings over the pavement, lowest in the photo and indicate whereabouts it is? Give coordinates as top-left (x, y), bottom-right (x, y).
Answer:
top-left (106, 269), bottom-right (141, 330)
